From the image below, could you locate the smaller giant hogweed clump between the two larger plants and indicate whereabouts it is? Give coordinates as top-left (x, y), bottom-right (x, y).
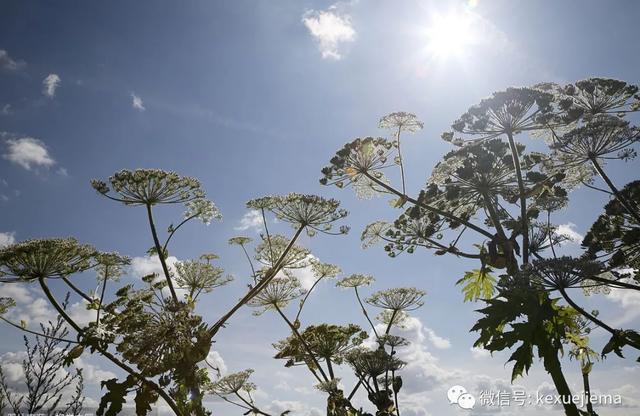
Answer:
top-left (220, 213), bottom-right (424, 416)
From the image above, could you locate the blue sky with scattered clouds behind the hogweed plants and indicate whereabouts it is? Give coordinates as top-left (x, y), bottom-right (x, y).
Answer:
top-left (0, 0), bottom-right (640, 415)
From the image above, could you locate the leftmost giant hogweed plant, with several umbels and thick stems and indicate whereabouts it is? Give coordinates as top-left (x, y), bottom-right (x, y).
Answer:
top-left (0, 169), bottom-right (360, 415)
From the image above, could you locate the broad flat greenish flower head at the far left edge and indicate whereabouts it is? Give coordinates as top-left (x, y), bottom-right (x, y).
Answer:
top-left (0, 238), bottom-right (97, 282)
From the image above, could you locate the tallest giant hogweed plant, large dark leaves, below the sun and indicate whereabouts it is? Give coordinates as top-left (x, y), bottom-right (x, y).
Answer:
top-left (320, 78), bottom-right (640, 416)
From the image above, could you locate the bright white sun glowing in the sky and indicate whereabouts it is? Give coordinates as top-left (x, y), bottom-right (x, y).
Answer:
top-left (426, 13), bottom-right (475, 58)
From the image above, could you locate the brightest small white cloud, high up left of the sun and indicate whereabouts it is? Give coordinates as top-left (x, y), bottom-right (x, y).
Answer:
top-left (302, 5), bottom-right (356, 60)
